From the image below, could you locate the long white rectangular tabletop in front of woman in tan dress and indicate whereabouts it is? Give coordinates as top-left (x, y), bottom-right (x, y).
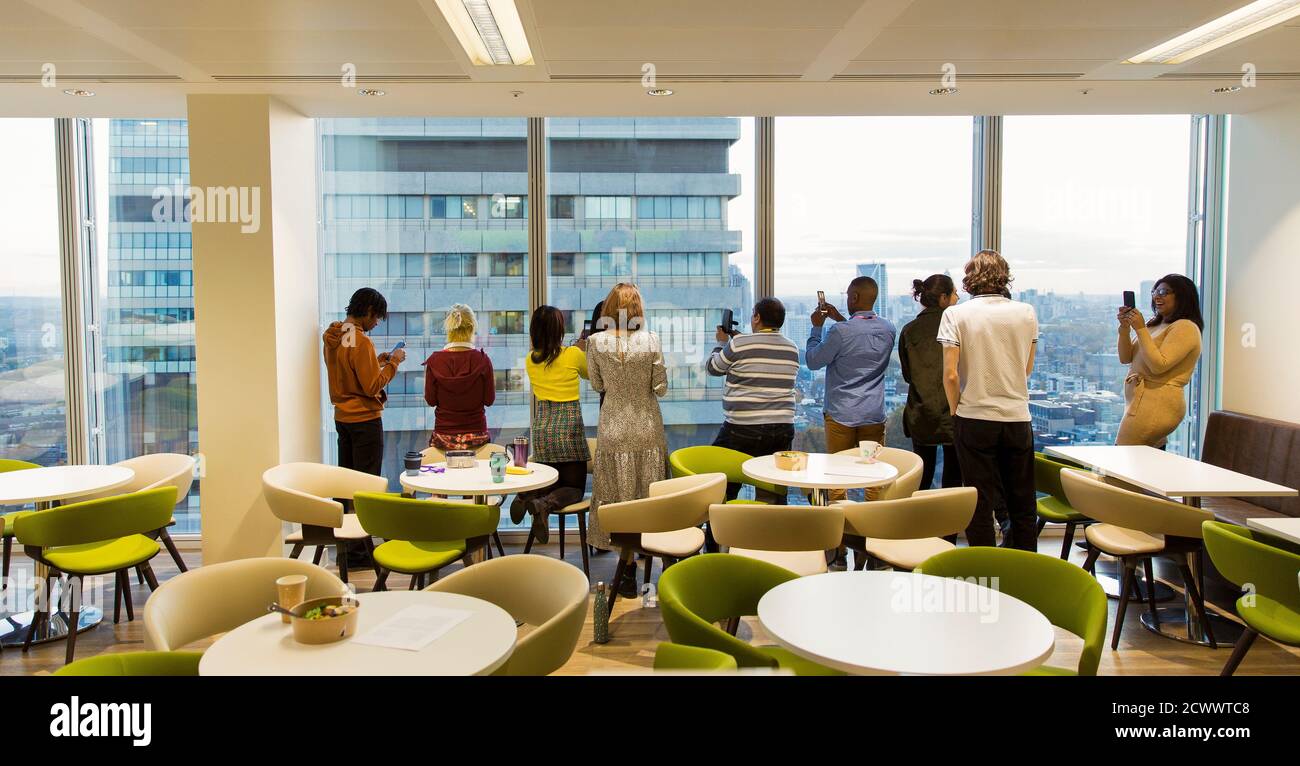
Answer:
top-left (1045, 446), bottom-right (1296, 497)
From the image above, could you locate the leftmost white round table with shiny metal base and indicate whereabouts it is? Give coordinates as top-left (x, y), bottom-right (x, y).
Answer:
top-left (0, 466), bottom-right (135, 646)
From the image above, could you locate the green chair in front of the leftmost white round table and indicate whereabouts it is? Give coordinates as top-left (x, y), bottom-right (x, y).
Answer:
top-left (14, 485), bottom-right (176, 662)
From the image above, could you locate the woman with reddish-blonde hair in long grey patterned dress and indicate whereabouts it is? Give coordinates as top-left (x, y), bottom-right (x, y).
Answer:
top-left (586, 282), bottom-right (668, 585)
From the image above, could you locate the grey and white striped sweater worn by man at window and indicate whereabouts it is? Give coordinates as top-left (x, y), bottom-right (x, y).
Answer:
top-left (709, 332), bottom-right (800, 425)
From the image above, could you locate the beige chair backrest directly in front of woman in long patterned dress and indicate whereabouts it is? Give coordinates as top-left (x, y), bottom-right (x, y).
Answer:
top-left (597, 473), bottom-right (727, 533)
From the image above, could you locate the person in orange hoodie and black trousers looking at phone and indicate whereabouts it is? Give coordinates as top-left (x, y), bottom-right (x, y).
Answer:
top-left (321, 287), bottom-right (406, 476)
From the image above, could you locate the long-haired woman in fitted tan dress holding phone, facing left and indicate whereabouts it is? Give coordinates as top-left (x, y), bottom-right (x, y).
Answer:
top-left (1115, 274), bottom-right (1205, 449)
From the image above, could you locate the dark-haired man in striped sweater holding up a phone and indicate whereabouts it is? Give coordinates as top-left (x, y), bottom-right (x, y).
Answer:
top-left (709, 298), bottom-right (800, 503)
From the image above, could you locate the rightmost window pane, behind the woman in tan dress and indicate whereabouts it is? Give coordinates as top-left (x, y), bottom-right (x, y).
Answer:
top-left (1002, 114), bottom-right (1191, 453)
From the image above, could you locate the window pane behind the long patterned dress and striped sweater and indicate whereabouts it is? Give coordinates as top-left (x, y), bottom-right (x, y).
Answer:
top-left (546, 117), bottom-right (754, 450)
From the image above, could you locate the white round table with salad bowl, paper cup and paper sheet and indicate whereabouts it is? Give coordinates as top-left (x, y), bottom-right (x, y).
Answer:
top-left (199, 590), bottom-right (517, 676)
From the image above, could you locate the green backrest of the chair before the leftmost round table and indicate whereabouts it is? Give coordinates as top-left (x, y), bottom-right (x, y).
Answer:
top-left (13, 485), bottom-right (176, 548)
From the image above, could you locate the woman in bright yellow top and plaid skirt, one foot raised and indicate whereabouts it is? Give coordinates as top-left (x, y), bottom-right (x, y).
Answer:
top-left (510, 306), bottom-right (590, 542)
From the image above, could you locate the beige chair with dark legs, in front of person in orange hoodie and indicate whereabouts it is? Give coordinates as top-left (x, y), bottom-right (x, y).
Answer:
top-left (261, 463), bottom-right (389, 583)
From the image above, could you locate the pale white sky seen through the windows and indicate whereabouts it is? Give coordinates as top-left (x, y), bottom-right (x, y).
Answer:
top-left (0, 116), bottom-right (1191, 297)
